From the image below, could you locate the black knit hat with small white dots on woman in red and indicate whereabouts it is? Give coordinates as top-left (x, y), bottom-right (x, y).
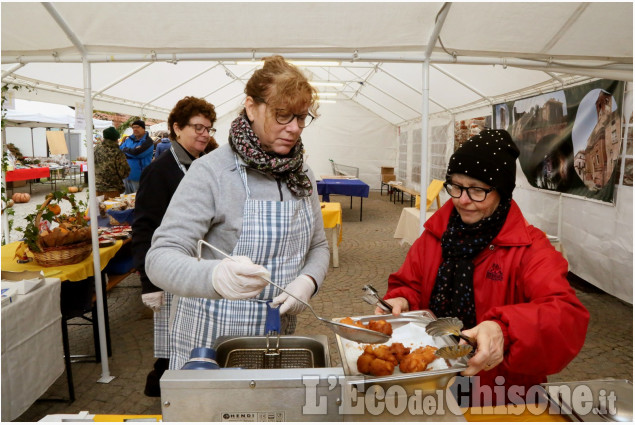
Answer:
top-left (446, 130), bottom-right (520, 199)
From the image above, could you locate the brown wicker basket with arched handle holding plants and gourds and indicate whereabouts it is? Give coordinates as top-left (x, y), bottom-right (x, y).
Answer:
top-left (33, 194), bottom-right (93, 267)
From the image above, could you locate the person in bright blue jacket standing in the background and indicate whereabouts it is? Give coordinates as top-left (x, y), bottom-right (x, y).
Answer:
top-left (119, 120), bottom-right (154, 193)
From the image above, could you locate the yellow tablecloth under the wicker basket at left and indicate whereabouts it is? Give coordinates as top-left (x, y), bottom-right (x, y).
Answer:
top-left (1, 240), bottom-right (123, 282)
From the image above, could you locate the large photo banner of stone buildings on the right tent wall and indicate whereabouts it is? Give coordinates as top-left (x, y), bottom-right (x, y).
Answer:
top-left (494, 80), bottom-right (624, 202)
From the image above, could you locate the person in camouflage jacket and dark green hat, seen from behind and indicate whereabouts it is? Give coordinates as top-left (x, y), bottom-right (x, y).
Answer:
top-left (95, 127), bottom-right (130, 199)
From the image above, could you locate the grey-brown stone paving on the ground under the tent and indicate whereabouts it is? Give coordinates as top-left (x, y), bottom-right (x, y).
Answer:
top-left (17, 192), bottom-right (633, 421)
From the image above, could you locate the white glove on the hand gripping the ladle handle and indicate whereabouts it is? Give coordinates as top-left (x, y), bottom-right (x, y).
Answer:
top-left (212, 256), bottom-right (271, 300)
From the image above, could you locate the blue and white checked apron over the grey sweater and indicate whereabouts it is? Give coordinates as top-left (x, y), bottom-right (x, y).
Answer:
top-left (170, 158), bottom-right (315, 369)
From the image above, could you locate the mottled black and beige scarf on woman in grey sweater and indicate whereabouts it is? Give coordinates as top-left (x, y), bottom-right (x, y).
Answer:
top-left (229, 115), bottom-right (313, 197)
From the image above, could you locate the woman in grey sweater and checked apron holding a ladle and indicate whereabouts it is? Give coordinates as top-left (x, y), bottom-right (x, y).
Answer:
top-left (146, 56), bottom-right (329, 369)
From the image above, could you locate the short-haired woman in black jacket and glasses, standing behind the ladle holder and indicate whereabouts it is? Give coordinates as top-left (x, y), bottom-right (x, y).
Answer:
top-left (132, 96), bottom-right (216, 397)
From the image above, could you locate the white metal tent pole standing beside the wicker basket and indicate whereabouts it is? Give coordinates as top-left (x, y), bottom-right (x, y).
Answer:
top-left (84, 60), bottom-right (115, 384)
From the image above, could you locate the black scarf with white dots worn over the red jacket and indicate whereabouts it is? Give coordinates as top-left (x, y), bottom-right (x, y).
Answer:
top-left (430, 199), bottom-right (511, 329)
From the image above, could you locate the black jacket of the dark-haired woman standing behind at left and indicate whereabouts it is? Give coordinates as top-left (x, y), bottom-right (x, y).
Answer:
top-left (132, 142), bottom-right (201, 294)
